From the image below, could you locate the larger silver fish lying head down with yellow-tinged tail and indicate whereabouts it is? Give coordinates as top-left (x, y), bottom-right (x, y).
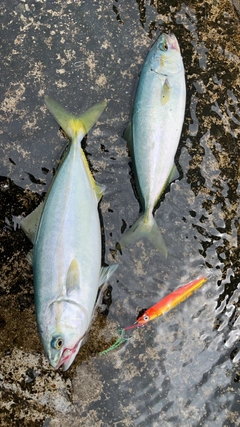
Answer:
top-left (21, 97), bottom-right (117, 371)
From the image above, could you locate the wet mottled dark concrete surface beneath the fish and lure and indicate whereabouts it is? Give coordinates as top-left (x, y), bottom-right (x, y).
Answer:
top-left (0, 0), bottom-right (240, 427)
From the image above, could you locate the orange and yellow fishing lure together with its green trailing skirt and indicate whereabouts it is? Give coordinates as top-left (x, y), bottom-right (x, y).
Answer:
top-left (100, 276), bottom-right (208, 356)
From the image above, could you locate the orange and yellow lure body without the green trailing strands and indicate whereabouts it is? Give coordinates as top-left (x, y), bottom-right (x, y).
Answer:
top-left (135, 277), bottom-right (207, 326)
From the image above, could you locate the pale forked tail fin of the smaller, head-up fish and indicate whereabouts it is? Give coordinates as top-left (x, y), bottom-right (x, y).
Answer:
top-left (119, 214), bottom-right (167, 258)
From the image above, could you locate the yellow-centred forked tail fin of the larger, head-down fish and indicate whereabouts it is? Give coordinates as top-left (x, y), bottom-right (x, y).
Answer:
top-left (44, 96), bottom-right (107, 139)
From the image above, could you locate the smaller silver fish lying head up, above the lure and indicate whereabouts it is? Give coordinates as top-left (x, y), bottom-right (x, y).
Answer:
top-left (120, 34), bottom-right (186, 256)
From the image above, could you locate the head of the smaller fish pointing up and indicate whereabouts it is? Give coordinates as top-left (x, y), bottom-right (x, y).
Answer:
top-left (151, 34), bottom-right (183, 76)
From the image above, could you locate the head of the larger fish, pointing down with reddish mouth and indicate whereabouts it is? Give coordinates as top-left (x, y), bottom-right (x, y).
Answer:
top-left (40, 300), bottom-right (89, 371)
